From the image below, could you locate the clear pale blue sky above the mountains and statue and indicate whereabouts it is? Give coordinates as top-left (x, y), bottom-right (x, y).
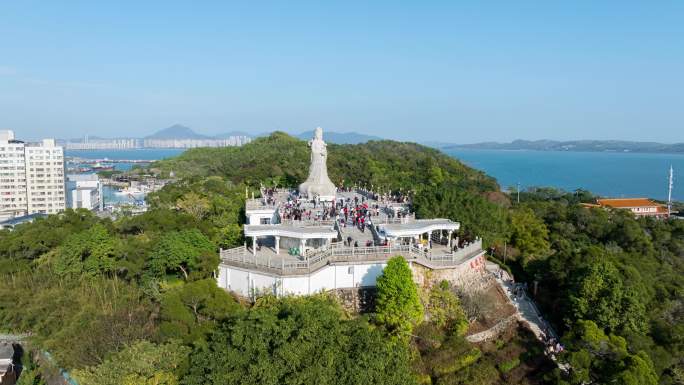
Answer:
top-left (0, 0), bottom-right (684, 143)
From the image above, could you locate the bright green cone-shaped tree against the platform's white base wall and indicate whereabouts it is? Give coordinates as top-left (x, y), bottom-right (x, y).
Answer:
top-left (375, 256), bottom-right (423, 334)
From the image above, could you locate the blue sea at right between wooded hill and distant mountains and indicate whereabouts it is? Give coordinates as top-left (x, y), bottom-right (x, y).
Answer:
top-left (447, 150), bottom-right (684, 201)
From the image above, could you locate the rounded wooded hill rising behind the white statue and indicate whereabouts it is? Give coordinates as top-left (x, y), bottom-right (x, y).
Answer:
top-left (155, 132), bottom-right (499, 192)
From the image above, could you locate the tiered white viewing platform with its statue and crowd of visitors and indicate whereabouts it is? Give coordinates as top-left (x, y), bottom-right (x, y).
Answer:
top-left (217, 130), bottom-right (485, 297)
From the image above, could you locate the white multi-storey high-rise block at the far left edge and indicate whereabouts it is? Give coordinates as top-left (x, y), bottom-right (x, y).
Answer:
top-left (0, 131), bottom-right (66, 219)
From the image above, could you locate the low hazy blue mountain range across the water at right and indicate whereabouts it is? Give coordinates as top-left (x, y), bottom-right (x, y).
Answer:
top-left (433, 140), bottom-right (684, 153)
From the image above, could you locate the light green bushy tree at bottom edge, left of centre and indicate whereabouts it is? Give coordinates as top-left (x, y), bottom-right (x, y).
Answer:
top-left (73, 341), bottom-right (190, 385)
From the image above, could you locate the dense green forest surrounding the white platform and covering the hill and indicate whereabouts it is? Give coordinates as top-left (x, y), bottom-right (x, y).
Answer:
top-left (0, 133), bottom-right (684, 385)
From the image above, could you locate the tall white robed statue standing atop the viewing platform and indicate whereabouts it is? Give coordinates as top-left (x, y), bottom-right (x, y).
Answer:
top-left (299, 127), bottom-right (337, 201)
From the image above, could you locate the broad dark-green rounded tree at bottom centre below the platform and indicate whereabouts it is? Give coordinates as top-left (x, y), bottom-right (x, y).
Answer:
top-left (183, 296), bottom-right (415, 385)
